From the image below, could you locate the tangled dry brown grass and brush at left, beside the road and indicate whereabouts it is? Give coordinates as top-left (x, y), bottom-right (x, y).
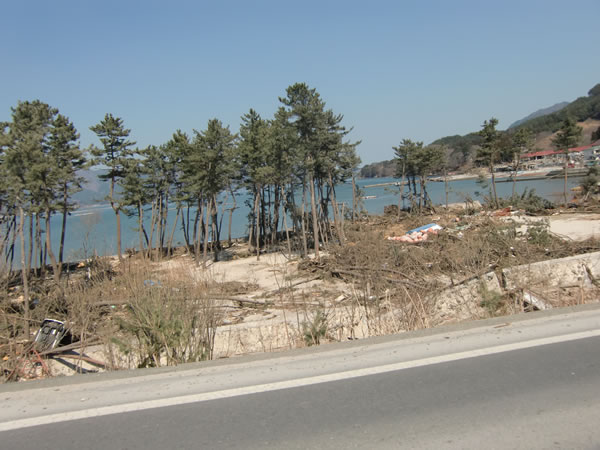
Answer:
top-left (0, 255), bottom-right (227, 379)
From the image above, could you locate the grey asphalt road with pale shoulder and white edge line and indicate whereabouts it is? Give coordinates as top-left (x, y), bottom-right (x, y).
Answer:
top-left (0, 311), bottom-right (600, 449)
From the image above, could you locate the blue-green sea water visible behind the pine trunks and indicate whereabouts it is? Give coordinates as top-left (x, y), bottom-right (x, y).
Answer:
top-left (2, 178), bottom-right (581, 267)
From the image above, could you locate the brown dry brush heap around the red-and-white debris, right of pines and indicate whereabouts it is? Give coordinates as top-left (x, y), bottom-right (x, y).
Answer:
top-left (302, 215), bottom-right (600, 335)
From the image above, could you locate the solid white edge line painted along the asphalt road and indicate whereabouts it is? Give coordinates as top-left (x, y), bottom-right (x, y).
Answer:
top-left (0, 329), bottom-right (600, 431)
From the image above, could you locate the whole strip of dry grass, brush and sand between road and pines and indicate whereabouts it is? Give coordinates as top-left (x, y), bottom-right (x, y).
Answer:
top-left (0, 209), bottom-right (600, 379)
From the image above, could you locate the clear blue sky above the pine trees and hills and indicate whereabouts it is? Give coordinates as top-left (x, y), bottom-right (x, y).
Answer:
top-left (0, 0), bottom-right (600, 163)
